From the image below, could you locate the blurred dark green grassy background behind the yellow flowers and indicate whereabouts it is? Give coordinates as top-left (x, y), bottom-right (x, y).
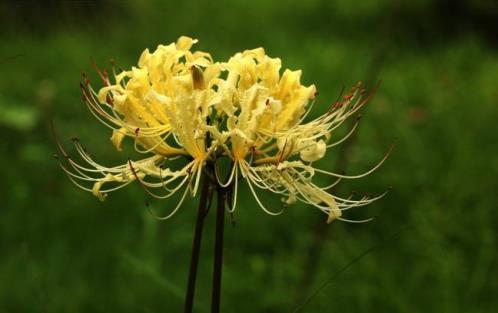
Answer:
top-left (0, 0), bottom-right (498, 313)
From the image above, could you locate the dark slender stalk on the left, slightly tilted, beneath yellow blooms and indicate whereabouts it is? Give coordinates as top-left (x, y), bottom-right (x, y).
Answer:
top-left (184, 175), bottom-right (212, 313)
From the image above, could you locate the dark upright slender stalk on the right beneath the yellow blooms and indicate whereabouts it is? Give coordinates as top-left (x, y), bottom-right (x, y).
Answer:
top-left (211, 186), bottom-right (226, 313)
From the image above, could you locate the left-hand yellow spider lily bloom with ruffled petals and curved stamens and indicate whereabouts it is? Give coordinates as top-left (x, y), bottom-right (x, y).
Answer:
top-left (62, 37), bottom-right (220, 212)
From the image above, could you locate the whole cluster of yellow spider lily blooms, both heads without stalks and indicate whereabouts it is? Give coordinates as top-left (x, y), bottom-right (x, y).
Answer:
top-left (54, 37), bottom-right (385, 222)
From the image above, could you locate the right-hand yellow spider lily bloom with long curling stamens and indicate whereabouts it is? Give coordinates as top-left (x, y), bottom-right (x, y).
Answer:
top-left (208, 48), bottom-right (392, 222)
